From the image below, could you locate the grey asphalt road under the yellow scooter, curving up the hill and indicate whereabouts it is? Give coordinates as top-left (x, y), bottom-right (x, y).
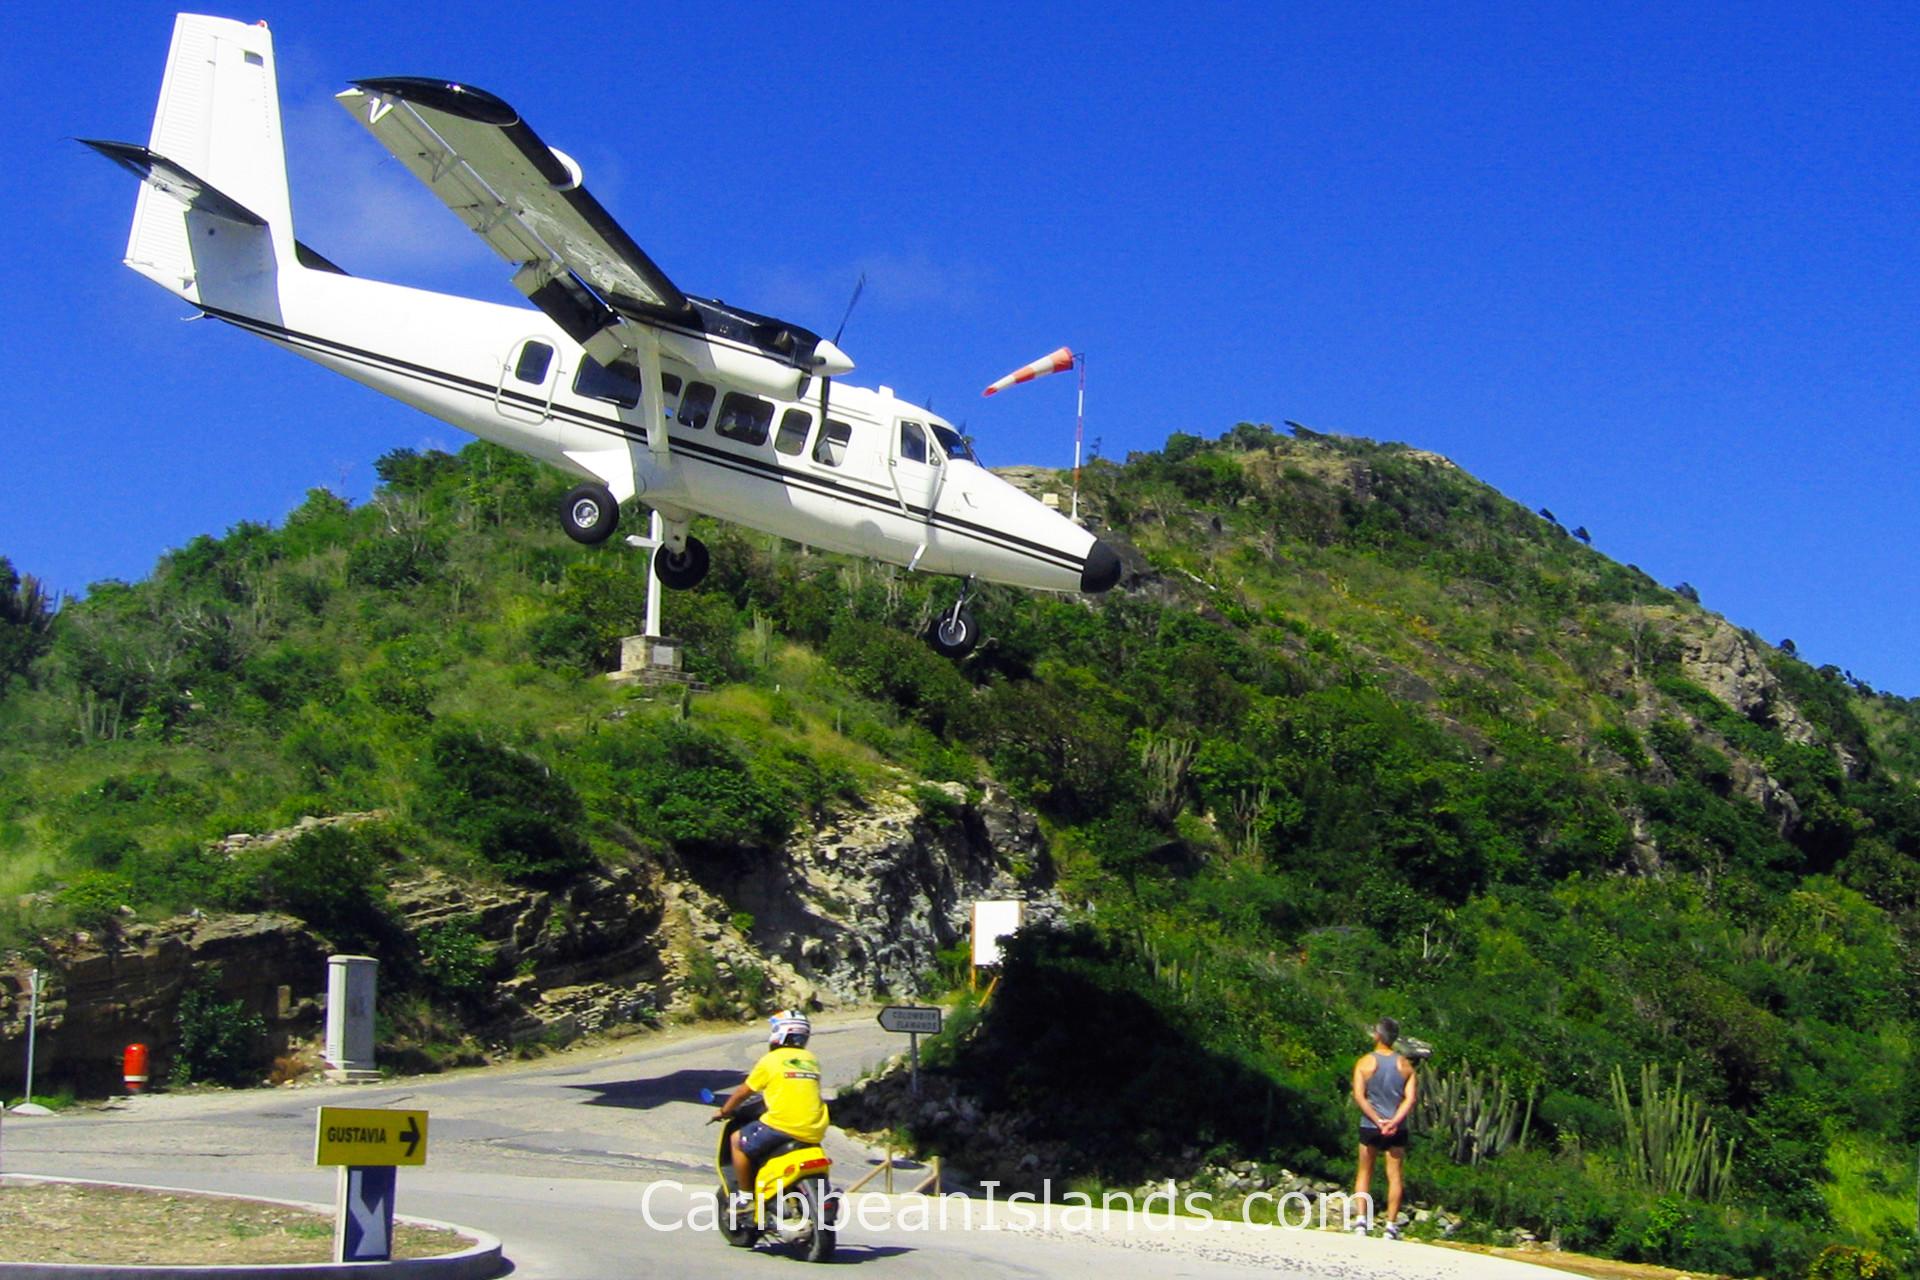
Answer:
top-left (0, 1013), bottom-right (1549, 1280)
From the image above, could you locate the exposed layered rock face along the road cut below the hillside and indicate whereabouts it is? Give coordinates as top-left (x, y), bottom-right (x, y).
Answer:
top-left (0, 783), bottom-right (1052, 1094)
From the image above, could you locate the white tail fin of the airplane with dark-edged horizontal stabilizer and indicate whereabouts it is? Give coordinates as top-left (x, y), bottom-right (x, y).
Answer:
top-left (86, 13), bottom-right (298, 315)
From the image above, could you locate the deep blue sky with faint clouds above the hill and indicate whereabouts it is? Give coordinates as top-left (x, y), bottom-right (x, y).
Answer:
top-left (0, 2), bottom-right (1920, 695)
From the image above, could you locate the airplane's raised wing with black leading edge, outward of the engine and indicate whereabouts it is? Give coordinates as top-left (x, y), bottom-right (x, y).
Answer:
top-left (338, 77), bottom-right (695, 342)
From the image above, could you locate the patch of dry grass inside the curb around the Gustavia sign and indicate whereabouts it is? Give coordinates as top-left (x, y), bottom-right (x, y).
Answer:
top-left (0, 1180), bottom-right (472, 1267)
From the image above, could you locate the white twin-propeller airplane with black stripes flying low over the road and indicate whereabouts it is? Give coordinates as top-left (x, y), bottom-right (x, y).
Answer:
top-left (83, 13), bottom-right (1121, 656)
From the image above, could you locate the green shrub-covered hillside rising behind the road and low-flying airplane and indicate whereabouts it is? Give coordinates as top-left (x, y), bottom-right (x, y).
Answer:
top-left (0, 424), bottom-right (1920, 1274)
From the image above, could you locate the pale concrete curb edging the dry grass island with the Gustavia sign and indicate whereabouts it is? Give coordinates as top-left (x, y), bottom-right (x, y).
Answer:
top-left (0, 1173), bottom-right (507, 1280)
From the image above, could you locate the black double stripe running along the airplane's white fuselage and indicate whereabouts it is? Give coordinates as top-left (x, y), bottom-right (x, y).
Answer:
top-left (200, 305), bottom-right (1085, 570)
